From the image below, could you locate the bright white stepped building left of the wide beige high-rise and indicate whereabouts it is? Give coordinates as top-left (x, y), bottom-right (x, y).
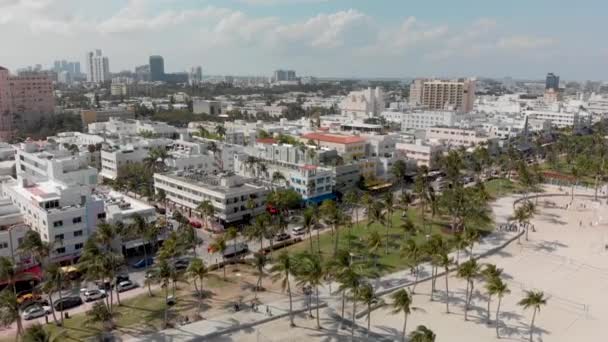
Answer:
top-left (340, 87), bottom-right (385, 118)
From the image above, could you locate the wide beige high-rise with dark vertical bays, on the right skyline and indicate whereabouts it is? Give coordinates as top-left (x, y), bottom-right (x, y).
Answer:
top-left (410, 78), bottom-right (476, 113)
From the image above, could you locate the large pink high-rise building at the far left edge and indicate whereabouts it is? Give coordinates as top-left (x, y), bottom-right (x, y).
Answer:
top-left (0, 67), bottom-right (55, 140)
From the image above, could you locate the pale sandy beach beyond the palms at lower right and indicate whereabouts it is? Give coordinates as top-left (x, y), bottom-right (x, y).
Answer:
top-left (372, 191), bottom-right (608, 342)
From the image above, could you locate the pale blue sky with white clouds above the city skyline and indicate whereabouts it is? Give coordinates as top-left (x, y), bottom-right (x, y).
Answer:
top-left (0, 0), bottom-right (608, 80)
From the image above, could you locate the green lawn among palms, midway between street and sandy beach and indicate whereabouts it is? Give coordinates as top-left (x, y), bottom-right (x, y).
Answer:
top-left (287, 208), bottom-right (491, 274)
